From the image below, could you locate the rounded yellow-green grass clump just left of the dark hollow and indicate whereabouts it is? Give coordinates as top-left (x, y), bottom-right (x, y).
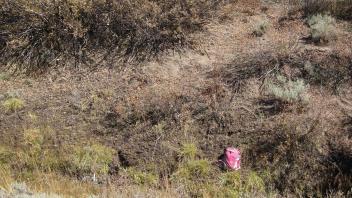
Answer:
top-left (70, 143), bottom-right (115, 175)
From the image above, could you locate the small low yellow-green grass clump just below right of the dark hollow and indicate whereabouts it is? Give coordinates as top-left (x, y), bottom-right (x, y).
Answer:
top-left (127, 168), bottom-right (159, 186)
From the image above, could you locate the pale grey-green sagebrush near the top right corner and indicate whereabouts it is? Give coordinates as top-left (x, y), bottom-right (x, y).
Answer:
top-left (308, 14), bottom-right (336, 42)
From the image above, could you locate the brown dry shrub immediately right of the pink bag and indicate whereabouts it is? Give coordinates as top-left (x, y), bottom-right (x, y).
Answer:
top-left (245, 117), bottom-right (325, 195)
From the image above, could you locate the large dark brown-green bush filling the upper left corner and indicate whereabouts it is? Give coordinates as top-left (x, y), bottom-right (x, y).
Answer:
top-left (0, 0), bottom-right (234, 72)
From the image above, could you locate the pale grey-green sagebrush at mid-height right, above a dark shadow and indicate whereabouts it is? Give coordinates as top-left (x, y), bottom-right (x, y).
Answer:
top-left (267, 75), bottom-right (308, 103)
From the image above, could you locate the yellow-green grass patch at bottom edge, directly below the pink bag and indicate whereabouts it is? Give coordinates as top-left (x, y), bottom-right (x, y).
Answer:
top-left (172, 166), bottom-right (267, 197)
